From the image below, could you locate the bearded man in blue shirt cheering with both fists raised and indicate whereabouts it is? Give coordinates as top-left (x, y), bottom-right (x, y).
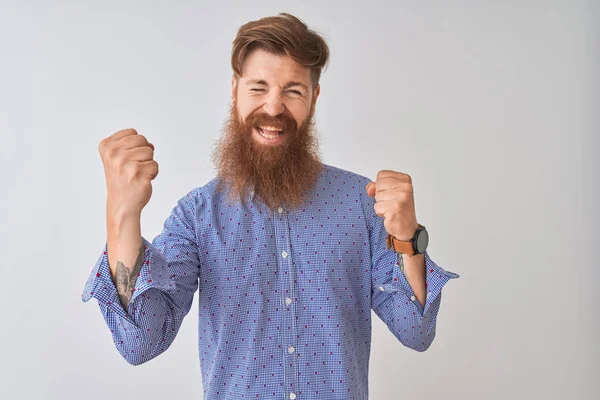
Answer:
top-left (83, 14), bottom-right (458, 400)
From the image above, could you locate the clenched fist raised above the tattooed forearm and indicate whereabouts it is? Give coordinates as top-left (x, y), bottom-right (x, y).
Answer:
top-left (98, 129), bottom-right (158, 214)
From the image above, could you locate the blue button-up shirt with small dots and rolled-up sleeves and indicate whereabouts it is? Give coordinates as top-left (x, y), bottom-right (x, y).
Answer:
top-left (82, 165), bottom-right (458, 400)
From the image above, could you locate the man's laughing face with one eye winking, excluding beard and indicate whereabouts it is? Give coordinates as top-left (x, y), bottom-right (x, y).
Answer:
top-left (231, 49), bottom-right (320, 146)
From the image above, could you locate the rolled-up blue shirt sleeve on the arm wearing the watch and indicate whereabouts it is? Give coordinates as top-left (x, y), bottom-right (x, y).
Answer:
top-left (364, 189), bottom-right (459, 351)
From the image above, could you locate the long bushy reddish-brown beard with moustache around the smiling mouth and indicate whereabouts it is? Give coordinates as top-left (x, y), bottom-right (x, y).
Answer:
top-left (213, 98), bottom-right (323, 210)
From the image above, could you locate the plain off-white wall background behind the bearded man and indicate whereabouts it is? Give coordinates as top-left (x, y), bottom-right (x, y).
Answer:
top-left (0, 0), bottom-right (600, 400)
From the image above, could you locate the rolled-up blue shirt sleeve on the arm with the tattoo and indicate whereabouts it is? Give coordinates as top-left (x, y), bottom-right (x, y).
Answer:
top-left (82, 193), bottom-right (200, 365)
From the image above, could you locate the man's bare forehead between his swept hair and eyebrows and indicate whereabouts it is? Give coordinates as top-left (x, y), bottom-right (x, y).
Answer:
top-left (242, 49), bottom-right (310, 86)
